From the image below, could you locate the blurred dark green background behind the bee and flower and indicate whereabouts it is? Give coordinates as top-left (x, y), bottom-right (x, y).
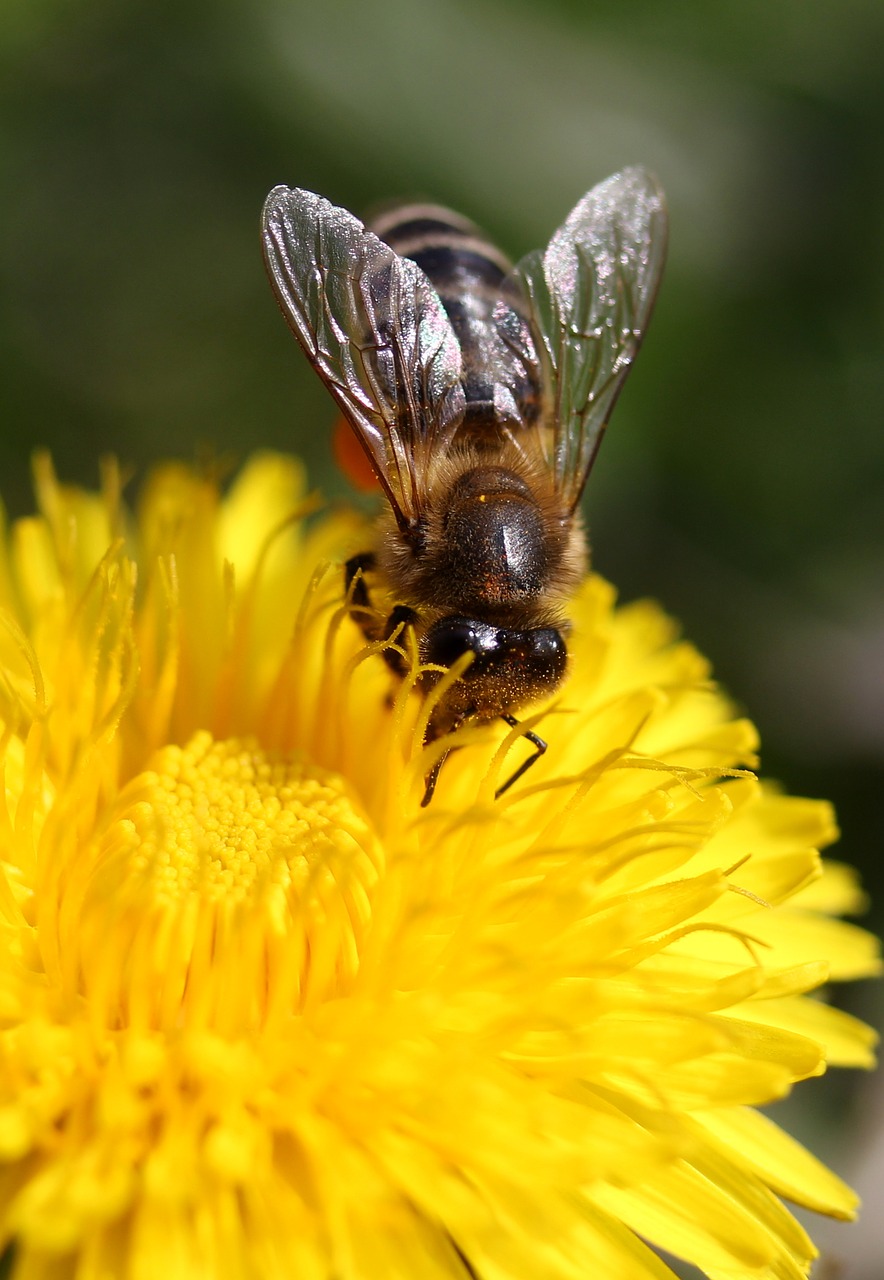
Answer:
top-left (0, 0), bottom-right (884, 1280)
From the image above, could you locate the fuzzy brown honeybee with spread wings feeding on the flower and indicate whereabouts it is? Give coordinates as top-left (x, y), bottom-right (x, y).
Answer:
top-left (262, 168), bottom-right (667, 805)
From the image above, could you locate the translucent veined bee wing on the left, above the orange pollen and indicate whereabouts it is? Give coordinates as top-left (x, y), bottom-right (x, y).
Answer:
top-left (261, 187), bottom-right (464, 531)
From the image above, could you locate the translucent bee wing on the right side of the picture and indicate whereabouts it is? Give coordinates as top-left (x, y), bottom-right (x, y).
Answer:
top-left (507, 168), bottom-right (667, 511)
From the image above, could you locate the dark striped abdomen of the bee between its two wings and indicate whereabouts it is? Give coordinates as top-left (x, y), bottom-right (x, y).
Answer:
top-left (370, 205), bottom-right (539, 438)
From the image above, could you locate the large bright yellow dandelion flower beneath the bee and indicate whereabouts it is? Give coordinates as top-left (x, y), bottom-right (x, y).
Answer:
top-left (0, 457), bottom-right (878, 1280)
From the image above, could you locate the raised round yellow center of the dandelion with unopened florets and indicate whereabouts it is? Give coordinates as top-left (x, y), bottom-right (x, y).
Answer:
top-left (74, 732), bottom-right (380, 1032)
